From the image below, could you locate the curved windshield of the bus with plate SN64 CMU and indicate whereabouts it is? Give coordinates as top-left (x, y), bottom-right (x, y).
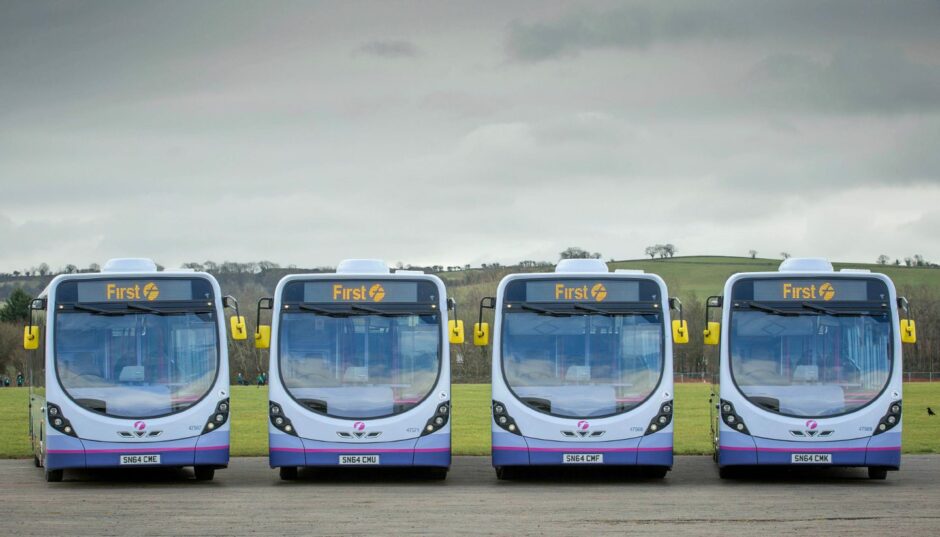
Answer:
top-left (278, 311), bottom-right (441, 419)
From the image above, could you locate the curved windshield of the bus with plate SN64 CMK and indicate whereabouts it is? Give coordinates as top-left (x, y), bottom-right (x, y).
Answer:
top-left (730, 309), bottom-right (892, 418)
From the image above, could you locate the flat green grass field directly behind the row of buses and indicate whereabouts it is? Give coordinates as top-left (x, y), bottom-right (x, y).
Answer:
top-left (0, 383), bottom-right (940, 458)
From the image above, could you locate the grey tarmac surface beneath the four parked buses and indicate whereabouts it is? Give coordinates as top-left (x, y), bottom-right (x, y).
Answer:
top-left (0, 455), bottom-right (940, 537)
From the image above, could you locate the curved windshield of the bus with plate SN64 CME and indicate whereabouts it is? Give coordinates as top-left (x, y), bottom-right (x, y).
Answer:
top-left (55, 311), bottom-right (219, 418)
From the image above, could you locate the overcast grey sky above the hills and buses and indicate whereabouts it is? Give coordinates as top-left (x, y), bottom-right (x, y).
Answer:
top-left (0, 0), bottom-right (940, 271)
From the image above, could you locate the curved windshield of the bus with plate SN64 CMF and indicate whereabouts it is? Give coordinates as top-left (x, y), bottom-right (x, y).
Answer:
top-left (501, 311), bottom-right (664, 418)
